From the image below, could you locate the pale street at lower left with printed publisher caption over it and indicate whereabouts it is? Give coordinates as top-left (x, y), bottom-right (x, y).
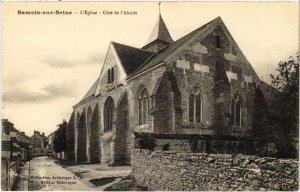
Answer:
top-left (29, 157), bottom-right (95, 191)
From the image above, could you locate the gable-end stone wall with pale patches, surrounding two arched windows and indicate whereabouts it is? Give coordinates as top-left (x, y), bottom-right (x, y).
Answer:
top-left (166, 27), bottom-right (260, 135)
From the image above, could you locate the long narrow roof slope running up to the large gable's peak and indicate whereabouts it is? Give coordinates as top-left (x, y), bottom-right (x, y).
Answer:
top-left (131, 17), bottom-right (221, 77)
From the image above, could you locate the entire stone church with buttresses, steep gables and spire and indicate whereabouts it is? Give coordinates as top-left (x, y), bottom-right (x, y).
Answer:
top-left (66, 15), bottom-right (281, 165)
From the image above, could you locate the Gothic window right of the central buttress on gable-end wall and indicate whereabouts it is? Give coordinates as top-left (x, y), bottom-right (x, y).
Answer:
top-left (231, 93), bottom-right (242, 127)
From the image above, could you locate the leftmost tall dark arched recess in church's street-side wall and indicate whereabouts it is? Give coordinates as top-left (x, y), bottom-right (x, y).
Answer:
top-left (77, 112), bottom-right (87, 162)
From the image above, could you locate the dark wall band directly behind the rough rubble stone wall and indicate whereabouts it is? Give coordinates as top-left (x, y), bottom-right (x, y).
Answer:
top-left (134, 132), bottom-right (298, 158)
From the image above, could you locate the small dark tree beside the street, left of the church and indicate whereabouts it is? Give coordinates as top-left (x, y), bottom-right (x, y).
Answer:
top-left (53, 120), bottom-right (68, 153)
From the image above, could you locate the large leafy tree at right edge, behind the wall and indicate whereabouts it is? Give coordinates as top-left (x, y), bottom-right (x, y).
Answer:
top-left (270, 52), bottom-right (299, 135)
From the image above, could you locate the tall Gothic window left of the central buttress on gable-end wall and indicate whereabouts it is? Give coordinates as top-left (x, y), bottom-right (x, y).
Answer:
top-left (189, 87), bottom-right (202, 123)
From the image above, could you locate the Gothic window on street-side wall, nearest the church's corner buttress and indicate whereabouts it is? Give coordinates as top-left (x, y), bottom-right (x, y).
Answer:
top-left (138, 88), bottom-right (149, 125)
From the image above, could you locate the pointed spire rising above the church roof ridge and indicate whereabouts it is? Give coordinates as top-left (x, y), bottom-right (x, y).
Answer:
top-left (144, 14), bottom-right (174, 47)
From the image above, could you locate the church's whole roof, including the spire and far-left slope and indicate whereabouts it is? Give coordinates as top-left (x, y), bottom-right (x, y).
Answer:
top-left (79, 15), bottom-right (254, 106)
